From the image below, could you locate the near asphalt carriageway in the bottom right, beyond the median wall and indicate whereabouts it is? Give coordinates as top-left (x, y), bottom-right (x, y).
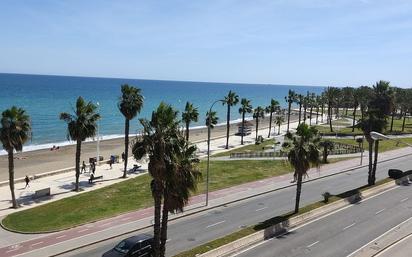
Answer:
top-left (237, 182), bottom-right (412, 257)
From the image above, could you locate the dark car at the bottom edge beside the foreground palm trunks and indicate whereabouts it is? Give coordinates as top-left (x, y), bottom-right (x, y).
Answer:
top-left (102, 234), bottom-right (153, 257)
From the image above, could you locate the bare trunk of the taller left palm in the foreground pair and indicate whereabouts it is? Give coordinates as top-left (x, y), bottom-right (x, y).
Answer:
top-left (153, 181), bottom-right (162, 257)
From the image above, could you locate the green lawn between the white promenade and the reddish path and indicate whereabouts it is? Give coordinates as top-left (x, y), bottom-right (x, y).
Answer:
top-left (3, 160), bottom-right (291, 232)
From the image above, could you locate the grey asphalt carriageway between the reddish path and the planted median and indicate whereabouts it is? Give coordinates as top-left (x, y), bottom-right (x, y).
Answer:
top-left (61, 154), bottom-right (412, 257)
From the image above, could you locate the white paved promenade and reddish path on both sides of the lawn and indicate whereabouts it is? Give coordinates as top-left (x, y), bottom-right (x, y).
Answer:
top-left (0, 114), bottom-right (412, 256)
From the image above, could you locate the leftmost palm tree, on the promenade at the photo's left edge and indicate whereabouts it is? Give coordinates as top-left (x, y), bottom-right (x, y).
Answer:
top-left (0, 106), bottom-right (31, 208)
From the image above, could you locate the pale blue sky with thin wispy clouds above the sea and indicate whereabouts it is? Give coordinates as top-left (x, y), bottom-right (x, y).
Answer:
top-left (0, 0), bottom-right (412, 87)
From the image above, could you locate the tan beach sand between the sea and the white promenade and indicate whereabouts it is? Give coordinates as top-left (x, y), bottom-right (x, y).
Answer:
top-left (0, 116), bottom-right (296, 181)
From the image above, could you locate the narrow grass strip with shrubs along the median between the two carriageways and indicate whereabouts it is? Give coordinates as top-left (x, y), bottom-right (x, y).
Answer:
top-left (174, 178), bottom-right (392, 257)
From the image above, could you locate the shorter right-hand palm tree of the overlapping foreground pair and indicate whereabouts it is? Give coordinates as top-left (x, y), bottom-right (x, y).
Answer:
top-left (159, 136), bottom-right (201, 256)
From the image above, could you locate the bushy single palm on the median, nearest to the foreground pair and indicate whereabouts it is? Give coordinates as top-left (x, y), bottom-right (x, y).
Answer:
top-left (283, 123), bottom-right (320, 213)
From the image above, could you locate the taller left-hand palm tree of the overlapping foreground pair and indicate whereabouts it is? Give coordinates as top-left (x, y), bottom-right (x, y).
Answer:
top-left (132, 102), bottom-right (180, 256)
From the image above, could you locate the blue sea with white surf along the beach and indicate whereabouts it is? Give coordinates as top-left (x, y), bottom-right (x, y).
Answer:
top-left (0, 73), bottom-right (324, 154)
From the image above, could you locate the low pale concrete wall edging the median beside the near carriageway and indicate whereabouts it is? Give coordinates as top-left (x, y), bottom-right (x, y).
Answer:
top-left (199, 178), bottom-right (397, 257)
